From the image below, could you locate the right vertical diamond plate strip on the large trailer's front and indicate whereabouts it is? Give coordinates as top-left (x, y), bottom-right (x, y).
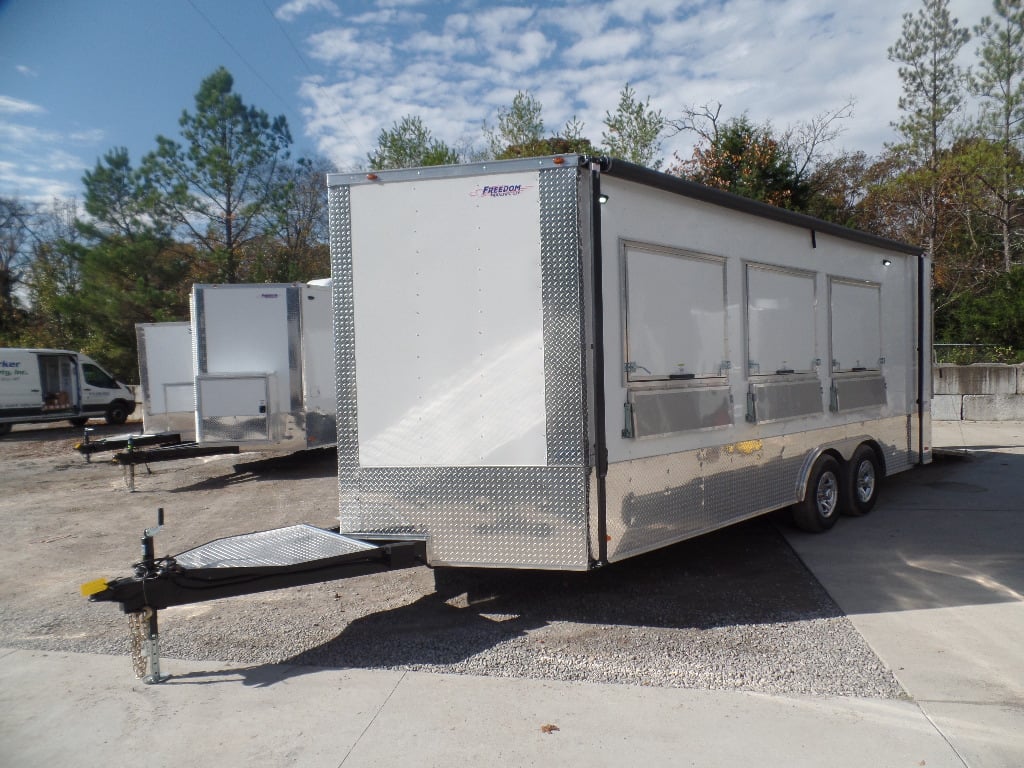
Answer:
top-left (540, 166), bottom-right (587, 467)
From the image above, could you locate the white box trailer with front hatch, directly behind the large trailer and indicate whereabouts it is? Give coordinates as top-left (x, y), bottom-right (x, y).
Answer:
top-left (191, 284), bottom-right (336, 451)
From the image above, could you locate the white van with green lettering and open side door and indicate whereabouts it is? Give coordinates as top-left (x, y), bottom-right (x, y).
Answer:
top-left (0, 347), bottom-right (135, 435)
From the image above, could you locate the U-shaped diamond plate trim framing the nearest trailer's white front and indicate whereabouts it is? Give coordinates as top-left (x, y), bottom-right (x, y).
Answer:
top-left (329, 167), bottom-right (590, 569)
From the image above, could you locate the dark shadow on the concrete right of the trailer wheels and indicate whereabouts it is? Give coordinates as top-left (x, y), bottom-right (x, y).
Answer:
top-left (787, 450), bottom-right (1024, 613)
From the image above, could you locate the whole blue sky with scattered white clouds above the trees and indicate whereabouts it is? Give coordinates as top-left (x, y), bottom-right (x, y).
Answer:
top-left (0, 0), bottom-right (991, 202)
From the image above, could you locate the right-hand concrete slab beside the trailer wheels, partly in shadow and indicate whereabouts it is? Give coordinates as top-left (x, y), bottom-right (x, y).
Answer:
top-left (786, 422), bottom-right (1024, 768)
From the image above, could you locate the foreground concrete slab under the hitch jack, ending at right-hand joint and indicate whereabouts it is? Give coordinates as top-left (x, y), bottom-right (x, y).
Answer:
top-left (0, 650), bottom-right (963, 768)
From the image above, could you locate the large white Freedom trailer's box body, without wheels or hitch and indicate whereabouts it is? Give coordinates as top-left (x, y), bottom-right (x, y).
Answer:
top-left (328, 156), bottom-right (930, 569)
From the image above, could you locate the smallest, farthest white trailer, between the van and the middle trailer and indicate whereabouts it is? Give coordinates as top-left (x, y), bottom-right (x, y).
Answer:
top-left (135, 322), bottom-right (196, 439)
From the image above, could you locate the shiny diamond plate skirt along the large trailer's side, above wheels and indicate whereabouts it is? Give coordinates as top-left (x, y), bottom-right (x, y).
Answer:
top-left (607, 416), bottom-right (914, 561)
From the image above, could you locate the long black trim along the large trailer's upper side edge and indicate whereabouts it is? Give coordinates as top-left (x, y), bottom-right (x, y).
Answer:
top-left (601, 158), bottom-right (925, 256)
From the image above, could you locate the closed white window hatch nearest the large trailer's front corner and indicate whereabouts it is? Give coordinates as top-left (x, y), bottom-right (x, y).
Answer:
top-left (624, 243), bottom-right (726, 381)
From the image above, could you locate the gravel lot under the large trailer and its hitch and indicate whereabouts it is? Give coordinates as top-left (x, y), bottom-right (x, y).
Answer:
top-left (0, 425), bottom-right (903, 698)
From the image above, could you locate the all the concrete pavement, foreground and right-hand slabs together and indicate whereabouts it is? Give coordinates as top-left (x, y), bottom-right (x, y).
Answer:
top-left (0, 422), bottom-right (1024, 768)
